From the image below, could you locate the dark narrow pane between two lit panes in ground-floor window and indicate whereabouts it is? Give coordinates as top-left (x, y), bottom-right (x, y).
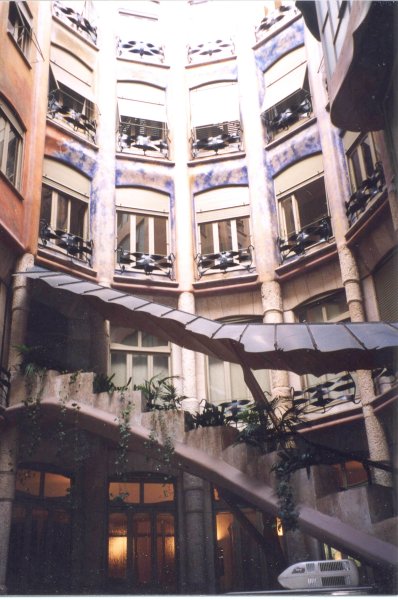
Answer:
top-left (133, 513), bottom-right (152, 584)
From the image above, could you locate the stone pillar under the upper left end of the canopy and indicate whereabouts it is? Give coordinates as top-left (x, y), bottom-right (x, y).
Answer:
top-left (8, 254), bottom-right (34, 379)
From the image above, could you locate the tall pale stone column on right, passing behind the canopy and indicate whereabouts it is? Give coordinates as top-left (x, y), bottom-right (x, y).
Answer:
top-left (306, 31), bottom-right (391, 485)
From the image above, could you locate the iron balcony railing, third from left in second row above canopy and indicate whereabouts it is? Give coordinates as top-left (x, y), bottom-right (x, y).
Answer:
top-left (191, 121), bottom-right (242, 158)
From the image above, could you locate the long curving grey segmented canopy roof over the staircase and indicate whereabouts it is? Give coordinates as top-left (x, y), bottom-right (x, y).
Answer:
top-left (19, 267), bottom-right (398, 376)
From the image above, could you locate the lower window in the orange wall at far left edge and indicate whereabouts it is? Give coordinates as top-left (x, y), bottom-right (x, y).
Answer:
top-left (0, 100), bottom-right (23, 189)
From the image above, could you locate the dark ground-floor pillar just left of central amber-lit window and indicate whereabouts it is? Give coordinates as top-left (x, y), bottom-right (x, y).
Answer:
top-left (80, 439), bottom-right (108, 594)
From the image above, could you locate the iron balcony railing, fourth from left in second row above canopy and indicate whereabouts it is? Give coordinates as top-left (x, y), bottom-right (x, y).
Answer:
top-left (262, 89), bottom-right (312, 142)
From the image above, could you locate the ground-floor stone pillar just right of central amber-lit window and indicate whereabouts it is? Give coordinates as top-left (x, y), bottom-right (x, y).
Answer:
top-left (182, 473), bottom-right (214, 594)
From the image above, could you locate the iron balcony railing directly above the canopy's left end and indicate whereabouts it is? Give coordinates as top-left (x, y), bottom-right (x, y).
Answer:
top-left (39, 220), bottom-right (94, 265)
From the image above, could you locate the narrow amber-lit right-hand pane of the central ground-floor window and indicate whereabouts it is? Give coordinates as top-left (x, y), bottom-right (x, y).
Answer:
top-left (156, 514), bottom-right (175, 584)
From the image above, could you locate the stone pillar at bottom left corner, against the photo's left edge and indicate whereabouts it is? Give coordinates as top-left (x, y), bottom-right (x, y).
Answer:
top-left (0, 428), bottom-right (18, 595)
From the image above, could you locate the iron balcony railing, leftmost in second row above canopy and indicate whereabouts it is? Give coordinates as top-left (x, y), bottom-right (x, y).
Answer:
top-left (47, 89), bottom-right (98, 143)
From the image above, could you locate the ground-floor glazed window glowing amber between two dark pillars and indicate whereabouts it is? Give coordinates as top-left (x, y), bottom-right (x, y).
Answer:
top-left (108, 477), bottom-right (177, 594)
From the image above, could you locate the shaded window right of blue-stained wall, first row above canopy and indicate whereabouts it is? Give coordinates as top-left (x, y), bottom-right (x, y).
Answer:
top-left (275, 155), bottom-right (332, 260)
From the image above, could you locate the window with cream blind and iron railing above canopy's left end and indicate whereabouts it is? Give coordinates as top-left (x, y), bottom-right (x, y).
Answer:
top-left (39, 159), bottom-right (92, 261)
